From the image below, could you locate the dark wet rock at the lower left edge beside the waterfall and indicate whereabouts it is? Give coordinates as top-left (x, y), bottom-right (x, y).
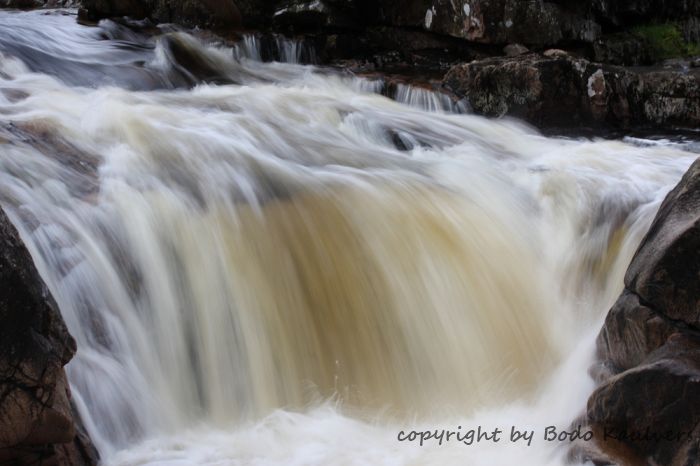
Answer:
top-left (0, 209), bottom-right (96, 464)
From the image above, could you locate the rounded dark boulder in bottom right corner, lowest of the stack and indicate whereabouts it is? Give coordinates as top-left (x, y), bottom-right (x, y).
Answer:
top-left (588, 334), bottom-right (700, 466)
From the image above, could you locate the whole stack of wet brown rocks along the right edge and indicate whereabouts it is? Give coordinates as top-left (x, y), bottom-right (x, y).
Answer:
top-left (588, 161), bottom-right (700, 466)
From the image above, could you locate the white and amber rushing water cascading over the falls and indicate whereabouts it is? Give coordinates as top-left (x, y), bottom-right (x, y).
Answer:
top-left (0, 12), bottom-right (697, 465)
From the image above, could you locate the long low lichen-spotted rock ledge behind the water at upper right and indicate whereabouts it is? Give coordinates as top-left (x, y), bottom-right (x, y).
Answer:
top-left (443, 49), bottom-right (700, 128)
